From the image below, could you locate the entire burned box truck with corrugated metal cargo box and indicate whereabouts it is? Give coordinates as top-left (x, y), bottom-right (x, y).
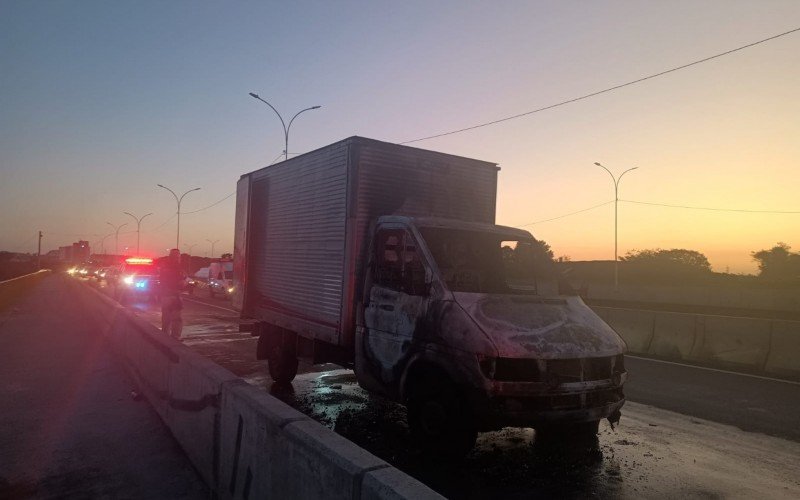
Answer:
top-left (233, 137), bottom-right (627, 453)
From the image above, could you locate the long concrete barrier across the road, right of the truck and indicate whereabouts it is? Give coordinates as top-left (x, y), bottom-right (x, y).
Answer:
top-left (592, 306), bottom-right (800, 378)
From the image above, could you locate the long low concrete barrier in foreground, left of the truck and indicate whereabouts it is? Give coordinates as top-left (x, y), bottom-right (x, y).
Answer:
top-left (75, 282), bottom-right (442, 499)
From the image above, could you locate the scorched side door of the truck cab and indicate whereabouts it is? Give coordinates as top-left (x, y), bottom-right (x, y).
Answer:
top-left (364, 229), bottom-right (428, 387)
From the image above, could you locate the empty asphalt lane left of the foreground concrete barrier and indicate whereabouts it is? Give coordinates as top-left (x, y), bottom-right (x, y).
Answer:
top-left (0, 275), bottom-right (210, 499)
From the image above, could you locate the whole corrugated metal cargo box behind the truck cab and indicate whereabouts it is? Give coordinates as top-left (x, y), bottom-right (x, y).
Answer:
top-left (237, 137), bottom-right (498, 345)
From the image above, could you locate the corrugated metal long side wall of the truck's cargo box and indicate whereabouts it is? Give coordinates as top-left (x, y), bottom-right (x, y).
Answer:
top-left (249, 143), bottom-right (347, 343)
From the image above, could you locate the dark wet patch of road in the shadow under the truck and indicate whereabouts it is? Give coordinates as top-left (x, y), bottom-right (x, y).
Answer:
top-left (270, 371), bottom-right (622, 498)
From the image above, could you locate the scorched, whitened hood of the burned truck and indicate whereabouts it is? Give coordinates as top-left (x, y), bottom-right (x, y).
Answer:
top-left (453, 293), bottom-right (625, 359)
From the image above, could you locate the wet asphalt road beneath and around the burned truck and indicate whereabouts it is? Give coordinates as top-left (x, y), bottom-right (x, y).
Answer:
top-left (89, 278), bottom-right (800, 498)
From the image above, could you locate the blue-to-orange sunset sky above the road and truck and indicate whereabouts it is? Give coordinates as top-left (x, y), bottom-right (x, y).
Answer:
top-left (0, 0), bottom-right (800, 273)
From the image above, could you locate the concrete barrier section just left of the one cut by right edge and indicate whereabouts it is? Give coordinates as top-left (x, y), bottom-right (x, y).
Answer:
top-left (691, 316), bottom-right (772, 370)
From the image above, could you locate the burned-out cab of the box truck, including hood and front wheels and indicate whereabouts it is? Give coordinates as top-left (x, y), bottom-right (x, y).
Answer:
top-left (355, 216), bottom-right (627, 450)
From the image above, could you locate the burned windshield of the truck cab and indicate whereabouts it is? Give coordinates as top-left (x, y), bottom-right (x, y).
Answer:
top-left (421, 228), bottom-right (552, 294)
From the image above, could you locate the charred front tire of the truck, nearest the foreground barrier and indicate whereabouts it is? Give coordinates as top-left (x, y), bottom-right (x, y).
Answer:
top-left (408, 382), bottom-right (478, 458)
